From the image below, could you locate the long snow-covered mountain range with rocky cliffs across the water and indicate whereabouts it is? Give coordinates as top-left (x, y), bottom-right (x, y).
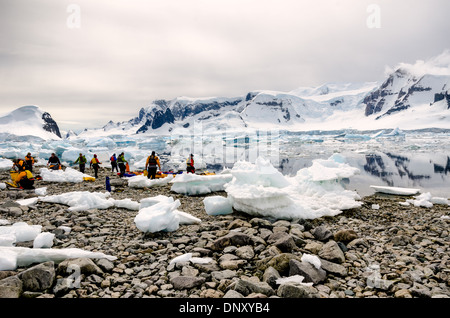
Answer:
top-left (82, 68), bottom-right (450, 134)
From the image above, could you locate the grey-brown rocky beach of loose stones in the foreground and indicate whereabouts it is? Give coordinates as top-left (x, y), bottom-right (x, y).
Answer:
top-left (0, 169), bottom-right (450, 298)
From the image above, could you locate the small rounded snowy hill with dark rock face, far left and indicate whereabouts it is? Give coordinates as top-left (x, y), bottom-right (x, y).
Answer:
top-left (0, 106), bottom-right (61, 140)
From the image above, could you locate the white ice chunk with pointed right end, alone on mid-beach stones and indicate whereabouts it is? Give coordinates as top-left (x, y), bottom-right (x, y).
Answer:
top-left (134, 195), bottom-right (201, 233)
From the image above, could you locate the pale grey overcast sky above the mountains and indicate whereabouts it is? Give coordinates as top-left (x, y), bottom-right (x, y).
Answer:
top-left (0, 0), bottom-right (450, 130)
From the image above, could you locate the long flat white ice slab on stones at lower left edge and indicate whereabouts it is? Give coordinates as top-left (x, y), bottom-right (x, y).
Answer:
top-left (0, 246), bottom-right (117, 270)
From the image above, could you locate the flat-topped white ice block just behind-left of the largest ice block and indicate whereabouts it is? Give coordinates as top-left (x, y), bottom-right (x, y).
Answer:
top-left (170, 173), bottom-right (232, 195)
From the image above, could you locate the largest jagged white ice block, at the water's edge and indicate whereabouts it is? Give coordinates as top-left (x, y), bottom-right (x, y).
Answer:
top-left (224, 155), bottom-right (362, 219)
